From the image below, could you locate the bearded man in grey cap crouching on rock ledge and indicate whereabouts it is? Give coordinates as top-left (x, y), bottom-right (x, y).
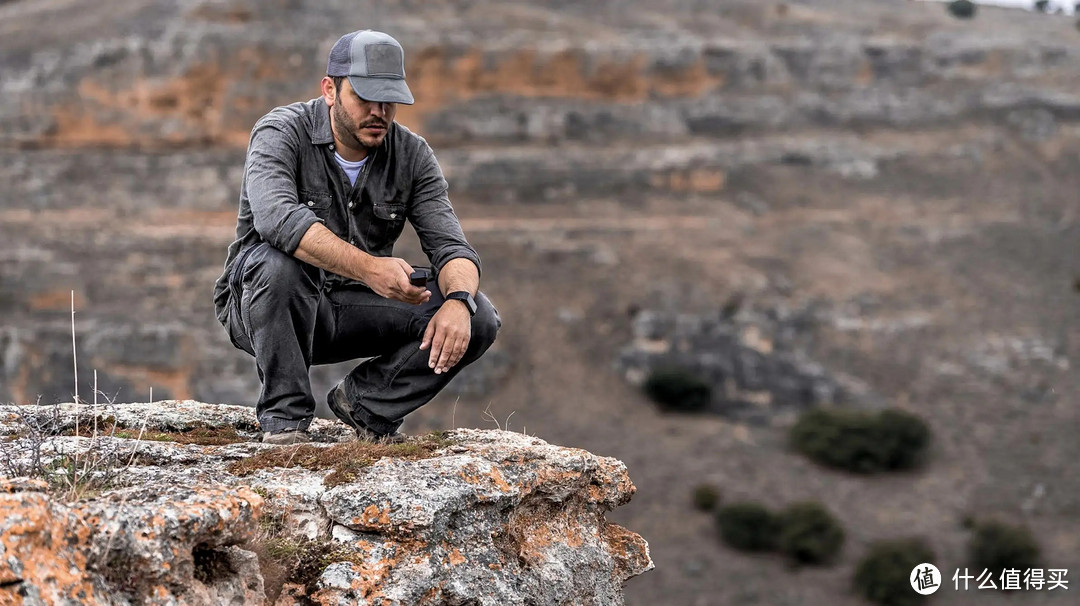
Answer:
top-left (214, 30), bottom-right (501, 444)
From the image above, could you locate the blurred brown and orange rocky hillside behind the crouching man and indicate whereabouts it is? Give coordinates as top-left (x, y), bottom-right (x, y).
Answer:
top-left (0, 0), bottom-right (1080, 606)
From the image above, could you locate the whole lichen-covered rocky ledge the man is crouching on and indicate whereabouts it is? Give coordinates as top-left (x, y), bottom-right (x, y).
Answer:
top-left (0, 401), bottom-right (653, 606)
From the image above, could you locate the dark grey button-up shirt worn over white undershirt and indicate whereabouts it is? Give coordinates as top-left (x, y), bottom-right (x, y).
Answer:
top-left (214, 97), bottom-right (481, 323)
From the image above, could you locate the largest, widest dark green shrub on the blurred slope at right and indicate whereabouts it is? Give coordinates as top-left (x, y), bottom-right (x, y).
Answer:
top-left (789, 408), bottom-right (930, 473)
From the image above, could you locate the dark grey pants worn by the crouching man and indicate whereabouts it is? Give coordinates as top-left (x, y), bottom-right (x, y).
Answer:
top-left (226, 242), bottom-right (502, 433)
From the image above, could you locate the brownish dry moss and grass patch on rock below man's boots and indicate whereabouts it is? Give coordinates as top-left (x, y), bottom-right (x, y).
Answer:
top-left (228, 432), bottom-right (454, 486)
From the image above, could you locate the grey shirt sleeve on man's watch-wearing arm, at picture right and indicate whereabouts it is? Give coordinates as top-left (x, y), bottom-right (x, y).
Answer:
top-left (408, 142), bottom-right (481, 273)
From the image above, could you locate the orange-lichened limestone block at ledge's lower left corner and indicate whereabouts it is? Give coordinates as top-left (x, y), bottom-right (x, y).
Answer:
top-left (0, 479), bottom-right (265, 606)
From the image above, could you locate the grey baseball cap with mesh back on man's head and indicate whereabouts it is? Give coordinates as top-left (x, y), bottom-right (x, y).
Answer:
top-left (326, 29), bottom-right (413, 105)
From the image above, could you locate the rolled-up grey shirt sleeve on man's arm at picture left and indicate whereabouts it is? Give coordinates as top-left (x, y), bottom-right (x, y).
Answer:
top-left (244, 122), bottom-right (324, 255)
